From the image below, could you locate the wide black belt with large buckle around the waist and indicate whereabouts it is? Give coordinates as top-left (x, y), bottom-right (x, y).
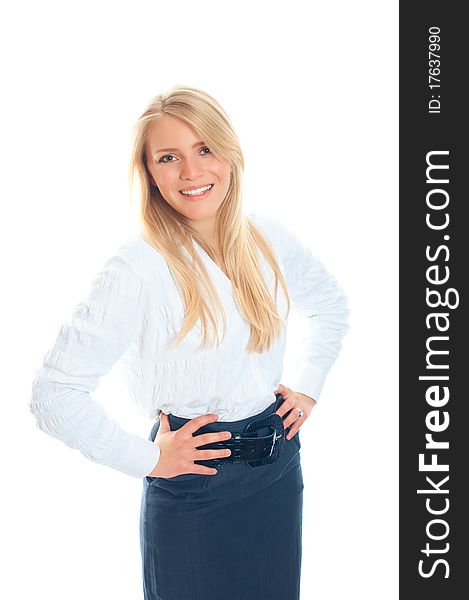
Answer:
top-left (192, 394), bottom-right (285, 467)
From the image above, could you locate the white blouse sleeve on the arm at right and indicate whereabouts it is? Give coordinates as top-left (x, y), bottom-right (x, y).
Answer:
top-left (284, 229), bottom-right (349, 401)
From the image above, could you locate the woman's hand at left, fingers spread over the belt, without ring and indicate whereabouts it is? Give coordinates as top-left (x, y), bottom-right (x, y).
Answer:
top-left (147, 412), bottom-right (231, 478)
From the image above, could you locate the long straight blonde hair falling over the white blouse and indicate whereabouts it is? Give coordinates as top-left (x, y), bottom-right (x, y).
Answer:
top-left (129, 85), bottom-right (290, 353)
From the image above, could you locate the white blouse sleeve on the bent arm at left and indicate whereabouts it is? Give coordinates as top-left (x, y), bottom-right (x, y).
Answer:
top-left (30, 255), bottom-right (160, 478)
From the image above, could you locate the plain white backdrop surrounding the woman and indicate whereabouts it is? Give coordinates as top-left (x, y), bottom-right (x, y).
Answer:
top-left (0, 0), bottom-right (398, 600)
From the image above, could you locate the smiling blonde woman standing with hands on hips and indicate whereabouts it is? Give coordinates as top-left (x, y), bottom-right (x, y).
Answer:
top-left (31, 86), bottom-right (348, 600)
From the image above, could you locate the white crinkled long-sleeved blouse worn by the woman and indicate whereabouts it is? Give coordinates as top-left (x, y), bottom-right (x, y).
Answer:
top-left (30, 212), bottom-right (349, 478)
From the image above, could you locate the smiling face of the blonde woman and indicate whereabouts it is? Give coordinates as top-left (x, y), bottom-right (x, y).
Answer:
top-left (146, 116), bottom-right (230, 235)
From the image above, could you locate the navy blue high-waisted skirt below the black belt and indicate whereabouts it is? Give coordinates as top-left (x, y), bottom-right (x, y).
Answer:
top-left (140, 396), bottom-right (303, 600)
